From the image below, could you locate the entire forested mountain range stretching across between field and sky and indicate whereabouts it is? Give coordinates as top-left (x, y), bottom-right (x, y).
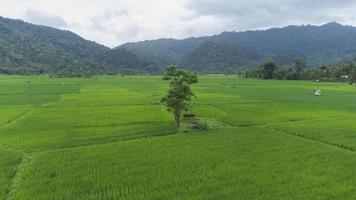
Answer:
top-left (0, 18), bottom-right (356, 74)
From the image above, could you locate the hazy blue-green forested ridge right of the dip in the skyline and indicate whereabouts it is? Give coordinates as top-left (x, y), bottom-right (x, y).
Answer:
top-left (120, 22), bottom-right (356, 72)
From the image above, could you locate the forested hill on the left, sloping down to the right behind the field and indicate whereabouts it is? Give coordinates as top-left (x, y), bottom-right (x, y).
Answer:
top-left (0, 17), bottom-right (155, 74)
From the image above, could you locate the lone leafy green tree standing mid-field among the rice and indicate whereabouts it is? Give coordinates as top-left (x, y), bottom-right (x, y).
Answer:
top-left (161, 66), bottom-right (198, 128)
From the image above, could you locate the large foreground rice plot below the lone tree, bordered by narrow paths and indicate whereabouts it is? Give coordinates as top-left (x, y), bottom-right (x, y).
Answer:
top-left (8, 128), bottom-right (356, 199)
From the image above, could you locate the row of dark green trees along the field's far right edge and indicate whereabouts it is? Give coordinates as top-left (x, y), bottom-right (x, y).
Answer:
top-left (237, 59), bottom-right (356, 82)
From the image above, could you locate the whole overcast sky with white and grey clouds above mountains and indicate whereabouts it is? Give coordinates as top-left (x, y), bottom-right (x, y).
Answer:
top-left (0, 0), bottom-right (356, 47)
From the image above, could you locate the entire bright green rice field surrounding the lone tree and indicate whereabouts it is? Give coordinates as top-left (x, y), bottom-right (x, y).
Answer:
top-left (0, 75), bottom-right (356, 200)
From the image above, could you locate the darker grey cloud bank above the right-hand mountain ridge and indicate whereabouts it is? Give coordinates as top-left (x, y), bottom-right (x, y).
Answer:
top-left (185, 0), bottom-right (356, 31)
